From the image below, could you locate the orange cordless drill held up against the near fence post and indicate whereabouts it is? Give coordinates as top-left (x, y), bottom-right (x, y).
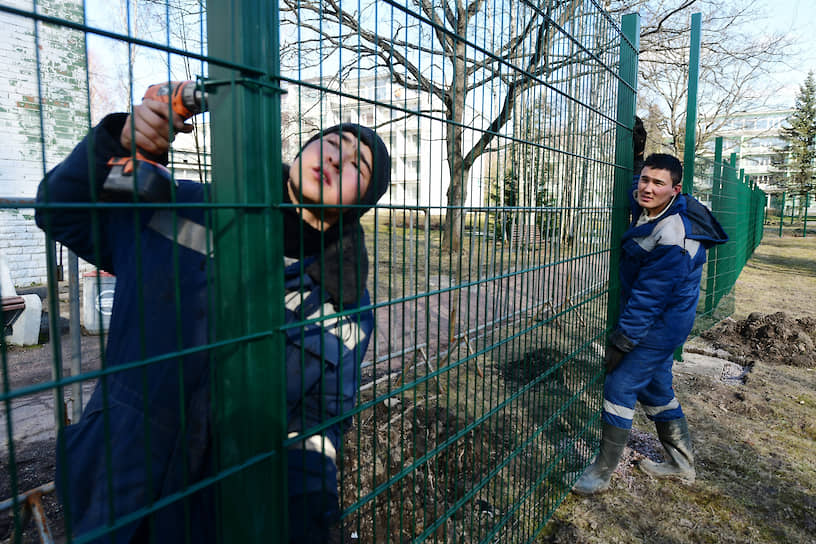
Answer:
top-left (100, 80), bottom-right (207, 202)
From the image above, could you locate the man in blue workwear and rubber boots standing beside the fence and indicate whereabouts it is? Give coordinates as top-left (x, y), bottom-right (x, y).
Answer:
top-left (573, 154), bottom-right (728, 495)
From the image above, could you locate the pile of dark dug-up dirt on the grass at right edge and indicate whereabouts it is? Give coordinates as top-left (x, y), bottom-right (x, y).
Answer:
top-left (701, 312), bottom-right (816, 368)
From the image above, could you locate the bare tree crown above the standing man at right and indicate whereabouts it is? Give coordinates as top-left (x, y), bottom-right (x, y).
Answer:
top-left (610, 0), bottom-right (791, 156)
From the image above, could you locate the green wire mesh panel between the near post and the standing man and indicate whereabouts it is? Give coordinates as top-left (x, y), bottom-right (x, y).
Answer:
top-left (287, 2), bottom-right (633, 542)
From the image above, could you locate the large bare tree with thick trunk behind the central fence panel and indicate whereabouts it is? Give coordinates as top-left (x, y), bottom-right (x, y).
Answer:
top-left (282, 0), bottom-right (617, 252)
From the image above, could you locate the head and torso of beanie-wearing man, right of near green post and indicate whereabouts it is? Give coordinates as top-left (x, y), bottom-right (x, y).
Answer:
top-left (283, 123), bottom-right (391, 543)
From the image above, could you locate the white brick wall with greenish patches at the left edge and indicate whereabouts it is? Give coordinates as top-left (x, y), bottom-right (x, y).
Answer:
top-left (0, 0), bottom-right (89, 286)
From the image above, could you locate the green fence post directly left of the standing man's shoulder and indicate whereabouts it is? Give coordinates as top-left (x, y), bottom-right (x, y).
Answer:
top-left (606, 13), bottom-right (640, 340)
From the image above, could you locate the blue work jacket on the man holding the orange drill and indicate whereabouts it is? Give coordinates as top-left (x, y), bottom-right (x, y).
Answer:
top-left (36, 114), bottom-right (373, 543)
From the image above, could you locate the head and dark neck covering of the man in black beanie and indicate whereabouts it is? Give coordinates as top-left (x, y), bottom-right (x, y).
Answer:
top-left (283, 123), bottom-right (391, 304)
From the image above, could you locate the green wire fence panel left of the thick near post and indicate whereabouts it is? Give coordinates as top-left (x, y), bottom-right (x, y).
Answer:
top-left (0, 1), bottom-right (223, 542)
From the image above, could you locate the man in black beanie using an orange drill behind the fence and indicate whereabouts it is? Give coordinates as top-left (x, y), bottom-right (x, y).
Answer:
top-left (36, 95), bottom-right (390, 543)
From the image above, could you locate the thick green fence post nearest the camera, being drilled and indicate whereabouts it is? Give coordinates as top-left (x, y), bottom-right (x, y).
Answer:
top-left (207, 0), bottom-right (287, 543)
